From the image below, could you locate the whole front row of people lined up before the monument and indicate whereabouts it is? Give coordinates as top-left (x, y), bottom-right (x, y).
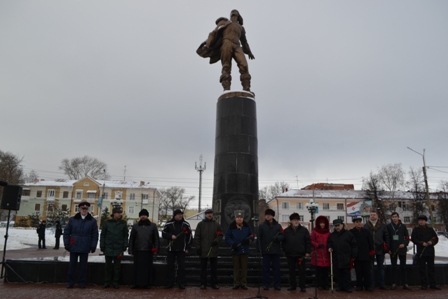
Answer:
top-left (58, 202), bottom-right (440, 292)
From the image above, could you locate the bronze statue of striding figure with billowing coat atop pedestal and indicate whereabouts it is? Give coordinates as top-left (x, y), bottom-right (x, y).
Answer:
top-left (196, 9), bottom-right (255, 91)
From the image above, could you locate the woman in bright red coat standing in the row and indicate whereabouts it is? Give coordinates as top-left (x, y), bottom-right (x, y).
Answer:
top-left (311, 216), bottom-right (330, 290)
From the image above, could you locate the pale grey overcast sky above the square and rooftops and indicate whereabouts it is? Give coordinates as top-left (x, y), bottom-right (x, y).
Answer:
top-left (0, 0), bottom-right (448, 211)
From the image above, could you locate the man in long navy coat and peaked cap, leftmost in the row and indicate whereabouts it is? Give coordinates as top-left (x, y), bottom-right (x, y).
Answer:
top-left (64, 202), bottom-right (98, 289)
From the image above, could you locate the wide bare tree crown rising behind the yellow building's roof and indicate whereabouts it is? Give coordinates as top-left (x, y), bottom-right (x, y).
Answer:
top-left (59, 156), bottom-right (109, 180)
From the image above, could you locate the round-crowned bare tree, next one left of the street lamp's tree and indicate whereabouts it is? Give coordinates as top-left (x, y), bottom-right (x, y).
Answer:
top-left (378, 163), bottom-right (405, 211)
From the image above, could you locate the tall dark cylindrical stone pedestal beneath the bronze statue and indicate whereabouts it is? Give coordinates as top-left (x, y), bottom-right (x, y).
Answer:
top-left (213, 91), bottom-right (258, 233)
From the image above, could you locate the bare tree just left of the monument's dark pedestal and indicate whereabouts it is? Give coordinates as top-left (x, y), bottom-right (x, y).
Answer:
top-left (159, 186), bottom-right (194, 219)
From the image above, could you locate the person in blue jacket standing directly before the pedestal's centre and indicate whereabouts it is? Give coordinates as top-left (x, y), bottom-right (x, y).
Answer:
top-left (226, 210), bottom-right (254, 290)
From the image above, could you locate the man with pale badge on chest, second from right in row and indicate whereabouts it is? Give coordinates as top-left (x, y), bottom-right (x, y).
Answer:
top-left (387, 212), bottom-right (411, 291)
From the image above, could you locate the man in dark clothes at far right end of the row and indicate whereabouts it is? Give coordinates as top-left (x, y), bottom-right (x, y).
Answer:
top-left (411, 215), bottom-right (440, 290)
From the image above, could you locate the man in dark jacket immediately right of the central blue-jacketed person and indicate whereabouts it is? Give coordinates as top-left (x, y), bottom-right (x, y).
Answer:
top-left (258, 209), bottom-right (285, 291)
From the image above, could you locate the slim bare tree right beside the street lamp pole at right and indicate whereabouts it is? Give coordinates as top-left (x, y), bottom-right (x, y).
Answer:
top-left (406, 167), bottom-right (426, 225)
